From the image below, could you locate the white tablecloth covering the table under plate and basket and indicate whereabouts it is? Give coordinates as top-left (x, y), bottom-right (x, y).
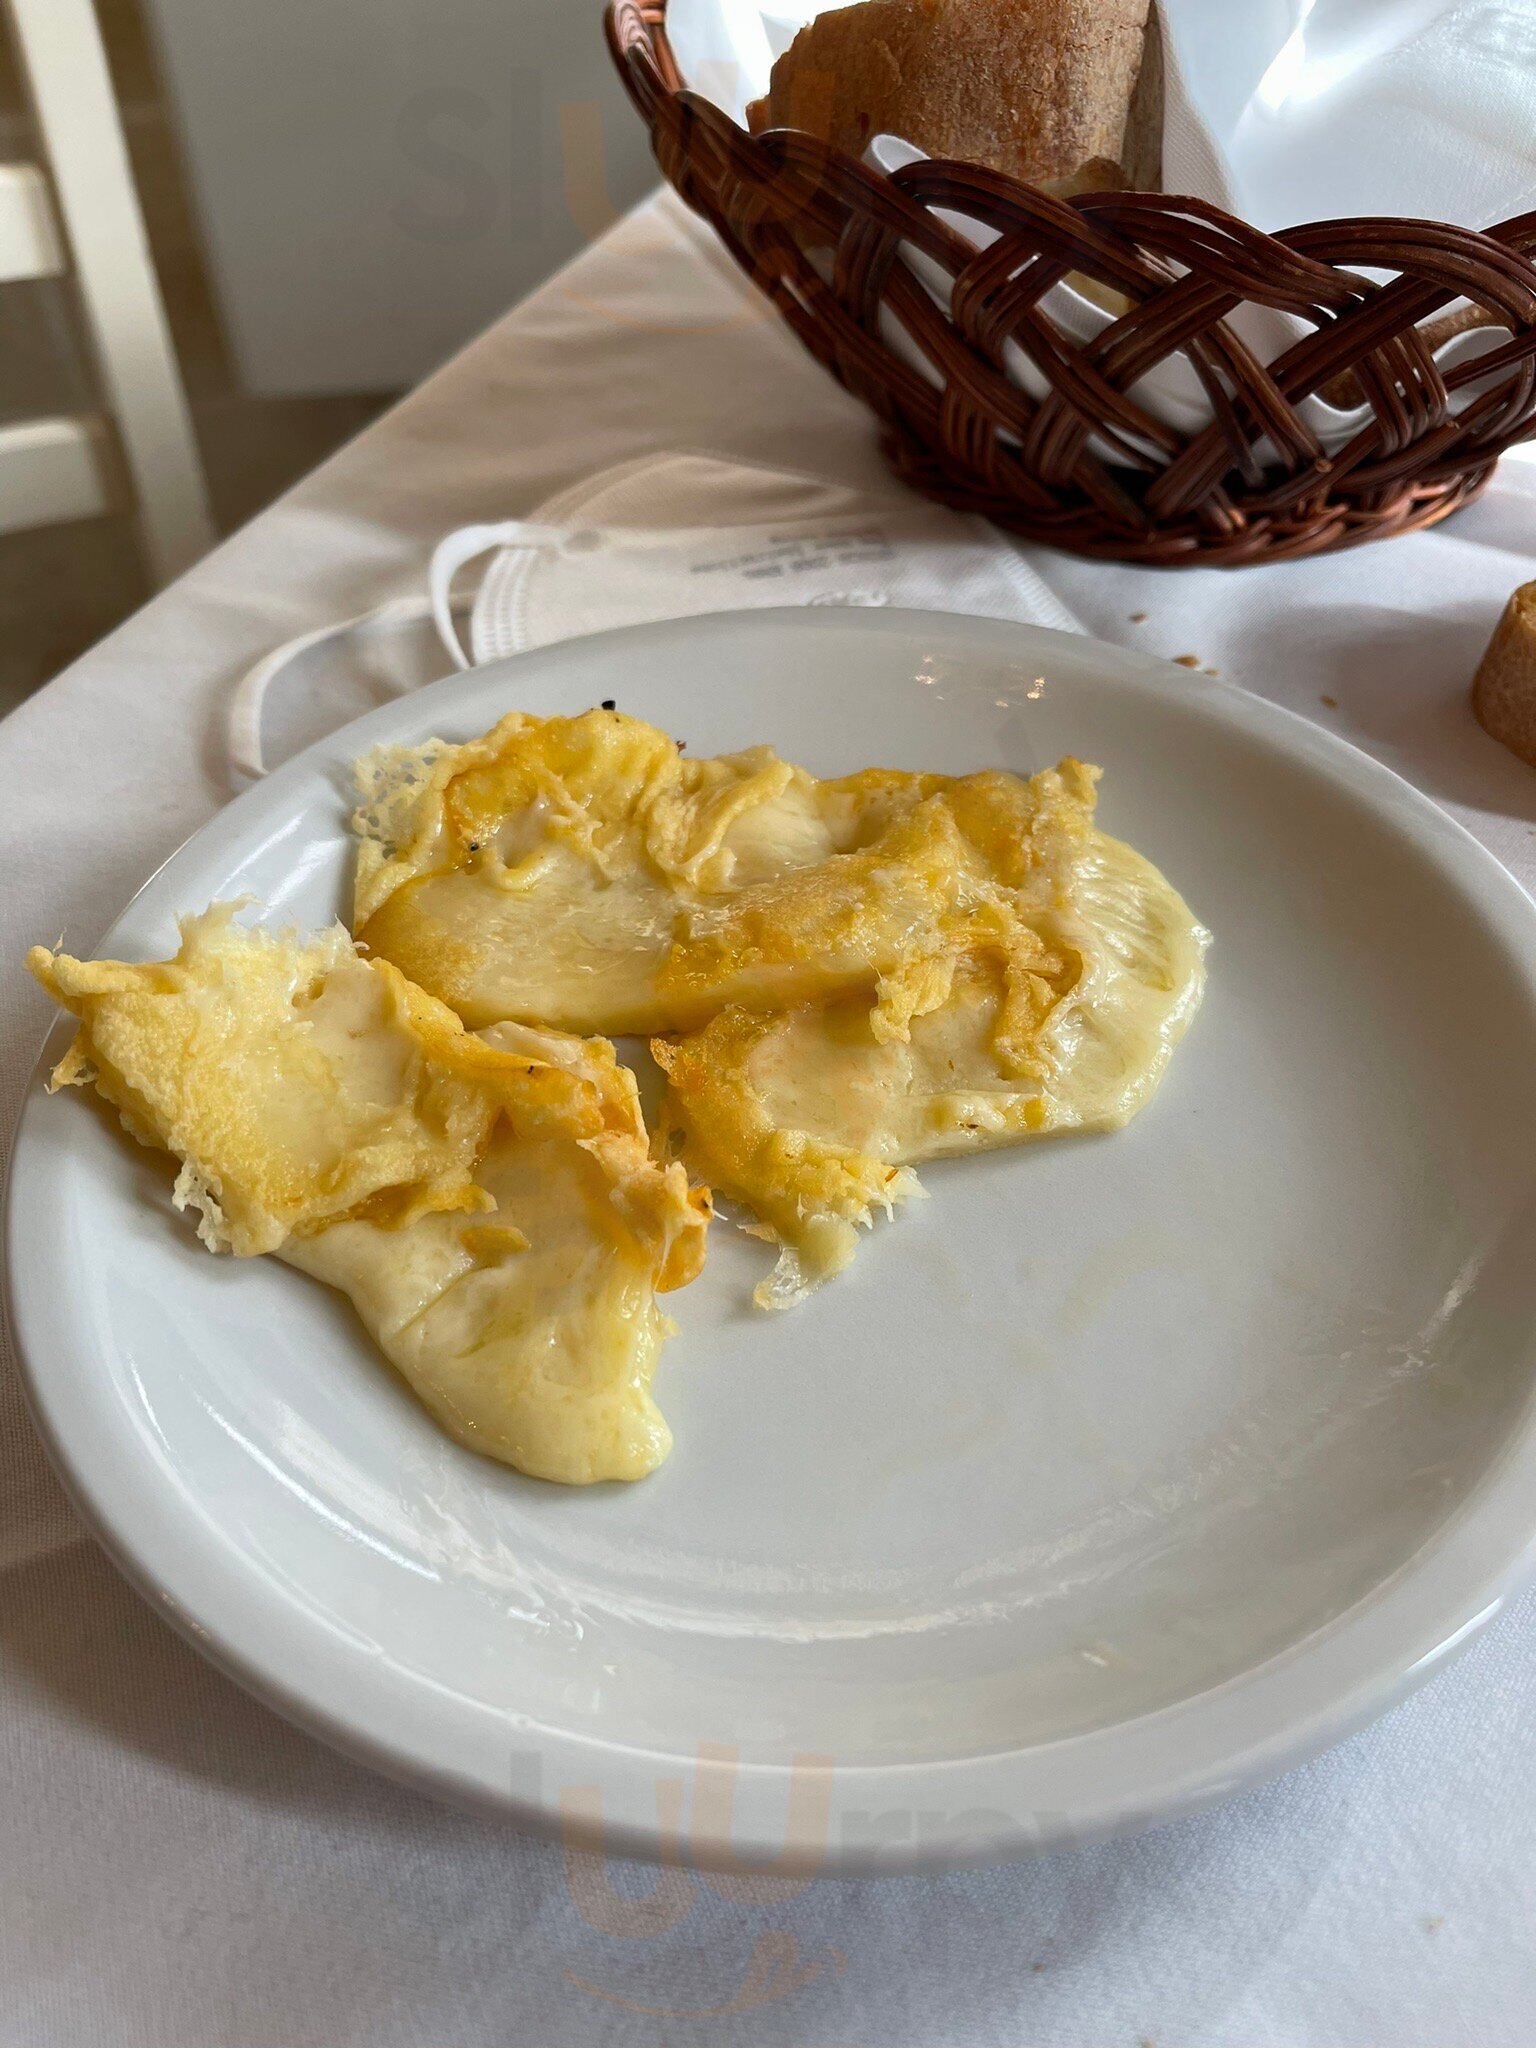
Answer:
top-left (0, 188), bottom-right (1536, 2048)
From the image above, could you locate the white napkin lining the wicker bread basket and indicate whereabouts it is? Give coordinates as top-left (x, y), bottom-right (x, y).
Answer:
top-left (668, 0), bottom-right (1536, 457)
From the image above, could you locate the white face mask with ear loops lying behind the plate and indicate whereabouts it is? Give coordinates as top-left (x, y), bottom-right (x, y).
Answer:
top-left (229, 453), bottom-right (1077, 780)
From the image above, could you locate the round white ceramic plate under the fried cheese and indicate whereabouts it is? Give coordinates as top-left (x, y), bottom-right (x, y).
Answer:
top-left (8, 610), bottom-right (1536, 1870)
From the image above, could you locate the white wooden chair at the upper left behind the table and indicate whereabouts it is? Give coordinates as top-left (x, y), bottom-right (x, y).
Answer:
top-left (0, 0), bottom-right (213, 584)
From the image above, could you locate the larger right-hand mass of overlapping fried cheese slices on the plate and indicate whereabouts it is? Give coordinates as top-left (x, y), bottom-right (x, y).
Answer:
top-left (356, 711), bottom-right (1206, 1307)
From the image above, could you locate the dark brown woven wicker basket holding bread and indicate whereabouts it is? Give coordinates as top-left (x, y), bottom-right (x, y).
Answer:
top-left (608, 0), bottom-right (1536, 565)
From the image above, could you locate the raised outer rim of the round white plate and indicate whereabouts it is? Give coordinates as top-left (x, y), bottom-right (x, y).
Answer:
top-left (4, 606), bottom-right (1536, 1876)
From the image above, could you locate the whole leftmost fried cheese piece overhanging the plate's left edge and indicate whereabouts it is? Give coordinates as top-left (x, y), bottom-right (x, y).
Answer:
top-left (29, 905), bottom-right (709, 1483)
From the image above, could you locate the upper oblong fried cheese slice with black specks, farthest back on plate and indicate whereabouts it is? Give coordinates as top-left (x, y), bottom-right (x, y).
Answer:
top-left (354, 711), bottom-right (1048, 1034)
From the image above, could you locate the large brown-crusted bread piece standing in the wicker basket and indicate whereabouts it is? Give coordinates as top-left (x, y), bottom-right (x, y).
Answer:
top-left (748, 0), bottom-right (1163, 193)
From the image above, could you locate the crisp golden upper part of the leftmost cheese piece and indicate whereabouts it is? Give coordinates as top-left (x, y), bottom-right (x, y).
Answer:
top-left (27, 903), bottom-right (704, 1264)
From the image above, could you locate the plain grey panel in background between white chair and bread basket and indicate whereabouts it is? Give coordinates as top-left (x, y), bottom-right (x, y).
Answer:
top-left (145, 0), bottom-right (655, 395)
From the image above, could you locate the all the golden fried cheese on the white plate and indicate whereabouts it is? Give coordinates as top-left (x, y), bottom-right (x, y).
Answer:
top-left (29, 707), bottom-right (1208, 1485)
